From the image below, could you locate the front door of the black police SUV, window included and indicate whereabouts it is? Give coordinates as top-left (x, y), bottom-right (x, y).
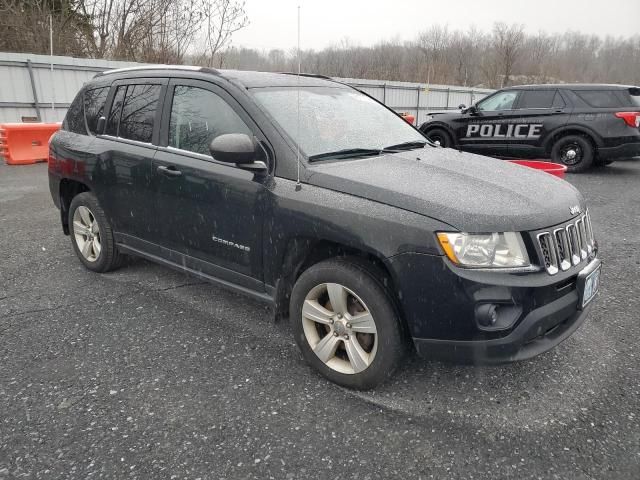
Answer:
top-left (455, 90), bottom-right (520, 156)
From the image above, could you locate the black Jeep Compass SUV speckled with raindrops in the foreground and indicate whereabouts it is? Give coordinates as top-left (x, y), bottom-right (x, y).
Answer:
top-left (49, 67), bottom-right (600, 388)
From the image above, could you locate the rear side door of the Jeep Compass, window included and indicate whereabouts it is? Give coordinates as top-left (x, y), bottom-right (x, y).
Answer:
top-left (94, 78), bottom-right (167, 250)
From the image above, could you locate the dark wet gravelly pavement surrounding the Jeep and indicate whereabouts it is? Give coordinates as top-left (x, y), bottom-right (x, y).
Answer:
top-left (0, 162), bottom-right (640, 480)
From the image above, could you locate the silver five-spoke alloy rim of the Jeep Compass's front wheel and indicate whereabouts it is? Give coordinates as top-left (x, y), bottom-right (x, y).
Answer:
top-left (302, 283), bottom-right (378, 374)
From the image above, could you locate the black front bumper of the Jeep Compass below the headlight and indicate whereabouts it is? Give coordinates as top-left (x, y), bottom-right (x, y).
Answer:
top-left (388, 255), bottom-right (600, 364)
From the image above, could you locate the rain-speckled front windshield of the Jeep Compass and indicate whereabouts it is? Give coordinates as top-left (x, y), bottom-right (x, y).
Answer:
top-left (252, 87), bottom-right (425, 157)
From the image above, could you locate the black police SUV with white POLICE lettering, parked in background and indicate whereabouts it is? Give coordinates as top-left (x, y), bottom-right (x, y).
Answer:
top-left (420, 84), bottom-right (640, 172)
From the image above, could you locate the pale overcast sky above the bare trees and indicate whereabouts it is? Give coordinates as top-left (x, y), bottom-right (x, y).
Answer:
top-left (233, 0), bottom-right (640, 50)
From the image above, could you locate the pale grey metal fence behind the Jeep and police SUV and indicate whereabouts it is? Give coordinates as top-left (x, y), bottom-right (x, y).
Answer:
top-left (0, 52), bottom-right (492, 125)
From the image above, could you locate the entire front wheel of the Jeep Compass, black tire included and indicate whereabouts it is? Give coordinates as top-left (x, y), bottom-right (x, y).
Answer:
top-left (290, 259), bottom-right (406, 390)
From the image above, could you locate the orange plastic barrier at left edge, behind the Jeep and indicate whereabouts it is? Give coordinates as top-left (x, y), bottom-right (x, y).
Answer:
top-left (0, 123), bottom-right (60, 165)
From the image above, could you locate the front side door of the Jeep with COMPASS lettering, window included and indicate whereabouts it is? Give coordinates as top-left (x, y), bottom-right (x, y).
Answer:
top-left (152, 79), bottom-right (268, 290)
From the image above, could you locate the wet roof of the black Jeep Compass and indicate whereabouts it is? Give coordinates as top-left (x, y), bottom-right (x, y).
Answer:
top-left (94, 65), bottom-right (349, 88)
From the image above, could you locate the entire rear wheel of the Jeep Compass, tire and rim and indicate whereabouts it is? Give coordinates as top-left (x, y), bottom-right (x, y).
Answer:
top-left (69, 192), bottom-right (122, 273)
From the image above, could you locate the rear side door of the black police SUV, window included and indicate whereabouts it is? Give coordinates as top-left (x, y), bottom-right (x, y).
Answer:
top-left (509, 88), bottom-right (571, 158)
